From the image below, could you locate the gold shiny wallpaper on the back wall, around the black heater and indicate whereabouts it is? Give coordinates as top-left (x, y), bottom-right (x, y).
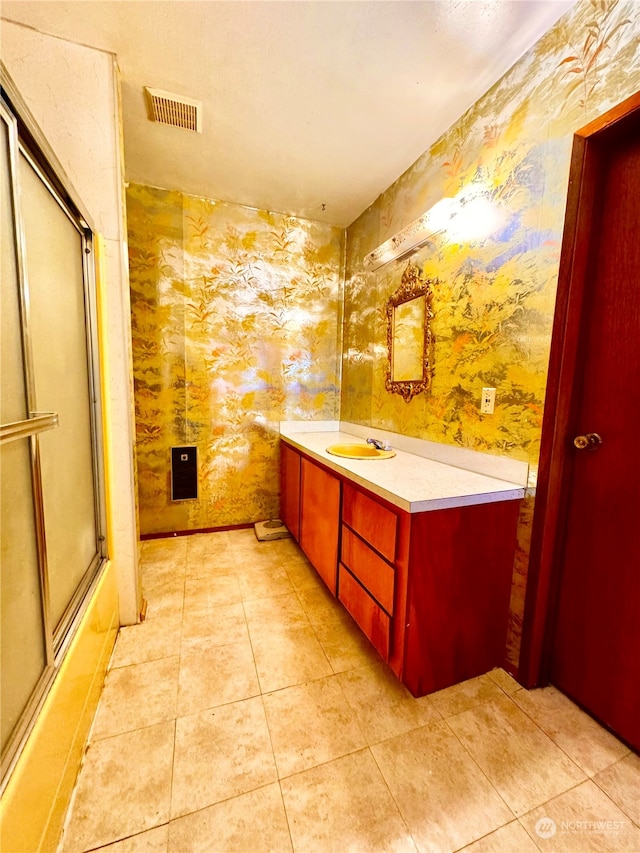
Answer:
top-left (127, 184), bottom-right (344, 534)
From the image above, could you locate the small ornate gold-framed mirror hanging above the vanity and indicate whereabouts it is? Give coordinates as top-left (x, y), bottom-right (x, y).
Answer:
top-left (385, 264), bottom-right (435, 403)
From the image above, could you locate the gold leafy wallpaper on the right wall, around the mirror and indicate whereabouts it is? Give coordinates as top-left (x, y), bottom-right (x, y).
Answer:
top-left (341, 0), bottom-right (640, 666)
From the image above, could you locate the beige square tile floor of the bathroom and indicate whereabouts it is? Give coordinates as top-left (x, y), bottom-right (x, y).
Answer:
top-left (62, 530), bottom-right (640, 853)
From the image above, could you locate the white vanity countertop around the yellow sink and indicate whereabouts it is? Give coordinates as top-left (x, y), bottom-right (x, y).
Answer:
top-left (280, 422), bottom-right (527, 513)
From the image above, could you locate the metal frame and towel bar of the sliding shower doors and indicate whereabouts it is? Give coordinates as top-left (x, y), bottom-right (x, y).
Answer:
top-left (0, 70), bottom-right (108, 792)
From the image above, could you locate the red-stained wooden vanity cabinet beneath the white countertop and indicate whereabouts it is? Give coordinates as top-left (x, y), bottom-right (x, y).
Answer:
top-left (281, 440), bottom-right (520, 696)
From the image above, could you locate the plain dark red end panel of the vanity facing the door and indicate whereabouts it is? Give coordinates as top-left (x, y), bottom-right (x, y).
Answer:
top-left (403, 501), bottom-right (518, 696)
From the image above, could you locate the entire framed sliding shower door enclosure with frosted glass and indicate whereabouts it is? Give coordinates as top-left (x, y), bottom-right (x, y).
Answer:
top-left (0, 83), bottom-right (106, 793)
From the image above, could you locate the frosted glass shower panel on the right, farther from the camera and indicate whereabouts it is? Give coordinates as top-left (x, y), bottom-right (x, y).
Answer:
top-left (19, 154), bottom-right (99, 626)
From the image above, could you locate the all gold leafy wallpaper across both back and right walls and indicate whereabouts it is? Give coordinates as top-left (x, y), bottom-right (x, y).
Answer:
top-left (127, 0), bottom-right (640, 667)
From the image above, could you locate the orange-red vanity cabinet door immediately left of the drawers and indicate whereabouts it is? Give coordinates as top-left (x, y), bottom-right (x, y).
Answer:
top-left (300, 459), bottom-right (340, 595)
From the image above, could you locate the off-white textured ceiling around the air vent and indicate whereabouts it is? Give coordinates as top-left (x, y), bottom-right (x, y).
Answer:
top-left (2, 0), bottom-right (575, 226)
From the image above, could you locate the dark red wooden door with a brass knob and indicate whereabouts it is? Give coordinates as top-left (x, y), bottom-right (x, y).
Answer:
top-left (551, 105), bottom-right (640, 749)
